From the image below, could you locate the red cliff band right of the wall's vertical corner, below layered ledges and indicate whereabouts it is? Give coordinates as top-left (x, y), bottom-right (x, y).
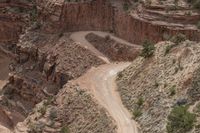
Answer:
top-left (114, 11), bottom-right (200, 44)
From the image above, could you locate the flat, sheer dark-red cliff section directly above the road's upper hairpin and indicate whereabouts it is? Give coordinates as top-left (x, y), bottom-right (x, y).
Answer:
top-left (61, 0), bottom-right (113, 31)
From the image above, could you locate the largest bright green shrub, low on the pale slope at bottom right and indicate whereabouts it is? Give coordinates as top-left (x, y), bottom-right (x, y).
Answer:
top-left (166, 106), bottom-right (196, 133)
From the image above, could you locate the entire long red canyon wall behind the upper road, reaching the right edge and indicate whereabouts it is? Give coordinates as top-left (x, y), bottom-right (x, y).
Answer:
top-left (38, 0), bottom-right (200, 44)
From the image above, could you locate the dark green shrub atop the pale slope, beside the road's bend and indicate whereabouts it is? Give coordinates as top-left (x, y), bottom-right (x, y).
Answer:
top-left (141, 40), bottom-right (155, 58)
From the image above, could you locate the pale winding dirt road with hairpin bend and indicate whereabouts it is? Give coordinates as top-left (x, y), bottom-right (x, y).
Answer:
top-left (71, 32), bottom-right (138, 133)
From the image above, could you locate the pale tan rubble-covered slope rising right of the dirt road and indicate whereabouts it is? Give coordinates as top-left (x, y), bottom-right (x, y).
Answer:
top-left (116, 41), bottom-right (200, 133)
